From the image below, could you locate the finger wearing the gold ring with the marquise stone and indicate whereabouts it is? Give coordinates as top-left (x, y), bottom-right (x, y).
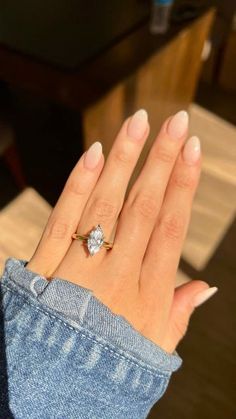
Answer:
top-left (63, 109), bottom-right (149, 270)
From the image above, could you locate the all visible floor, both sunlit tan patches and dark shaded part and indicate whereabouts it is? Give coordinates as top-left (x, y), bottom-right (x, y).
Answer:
top-left (0, 104), bottom-right (236, 419)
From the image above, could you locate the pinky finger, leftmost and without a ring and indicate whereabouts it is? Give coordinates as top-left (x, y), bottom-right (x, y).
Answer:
top-left (27, 141), bottom-right (104, 277)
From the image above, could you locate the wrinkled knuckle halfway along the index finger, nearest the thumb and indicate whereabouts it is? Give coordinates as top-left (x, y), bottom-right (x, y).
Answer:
top-left (160, 214), bottom-right (185, 240)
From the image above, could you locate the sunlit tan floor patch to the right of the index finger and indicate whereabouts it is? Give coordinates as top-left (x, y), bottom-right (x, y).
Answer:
top-left (183, 104), bottom-right (236, 270)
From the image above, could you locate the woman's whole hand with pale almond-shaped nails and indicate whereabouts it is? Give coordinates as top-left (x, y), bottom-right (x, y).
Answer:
top-left (27, 110), bottom-right (217, 353)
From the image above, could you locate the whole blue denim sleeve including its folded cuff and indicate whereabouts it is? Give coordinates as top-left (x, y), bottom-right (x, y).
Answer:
top-left (0, 258), bottom-right (182, 419)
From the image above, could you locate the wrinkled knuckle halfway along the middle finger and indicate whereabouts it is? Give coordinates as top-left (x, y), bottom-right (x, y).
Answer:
top-left (132, 194), bottom-right (159, 219)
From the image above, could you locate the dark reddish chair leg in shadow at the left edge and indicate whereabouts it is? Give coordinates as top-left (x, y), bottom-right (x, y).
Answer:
top-left (4, 143), bottom-right (27, 189)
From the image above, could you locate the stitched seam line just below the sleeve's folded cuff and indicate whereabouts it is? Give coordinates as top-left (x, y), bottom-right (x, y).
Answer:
top-left (1, 284), bottom-right (172, 378)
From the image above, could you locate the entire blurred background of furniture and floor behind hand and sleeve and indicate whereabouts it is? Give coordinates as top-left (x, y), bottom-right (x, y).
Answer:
top-left (0, 0), bottom-right (236, 419)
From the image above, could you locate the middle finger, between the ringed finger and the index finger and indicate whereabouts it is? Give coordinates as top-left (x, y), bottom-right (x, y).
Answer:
top-left (111, 111), bottom-right (188, 266)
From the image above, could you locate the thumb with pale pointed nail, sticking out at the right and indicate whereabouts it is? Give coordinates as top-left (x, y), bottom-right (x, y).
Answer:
top-left (163, 280), bottom-right (218, 353)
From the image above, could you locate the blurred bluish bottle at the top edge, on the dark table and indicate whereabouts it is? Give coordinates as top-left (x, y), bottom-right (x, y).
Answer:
top-left (149, 0), bottom-right (173, 34)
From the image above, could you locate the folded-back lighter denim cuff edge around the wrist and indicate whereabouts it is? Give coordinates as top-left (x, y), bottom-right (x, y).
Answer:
top-left (1, 258), bottom-right (182, 375)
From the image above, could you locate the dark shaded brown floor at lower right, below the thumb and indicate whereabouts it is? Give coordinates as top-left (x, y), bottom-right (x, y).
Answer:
top-left (149, 221), bottom-right (236, 419)
